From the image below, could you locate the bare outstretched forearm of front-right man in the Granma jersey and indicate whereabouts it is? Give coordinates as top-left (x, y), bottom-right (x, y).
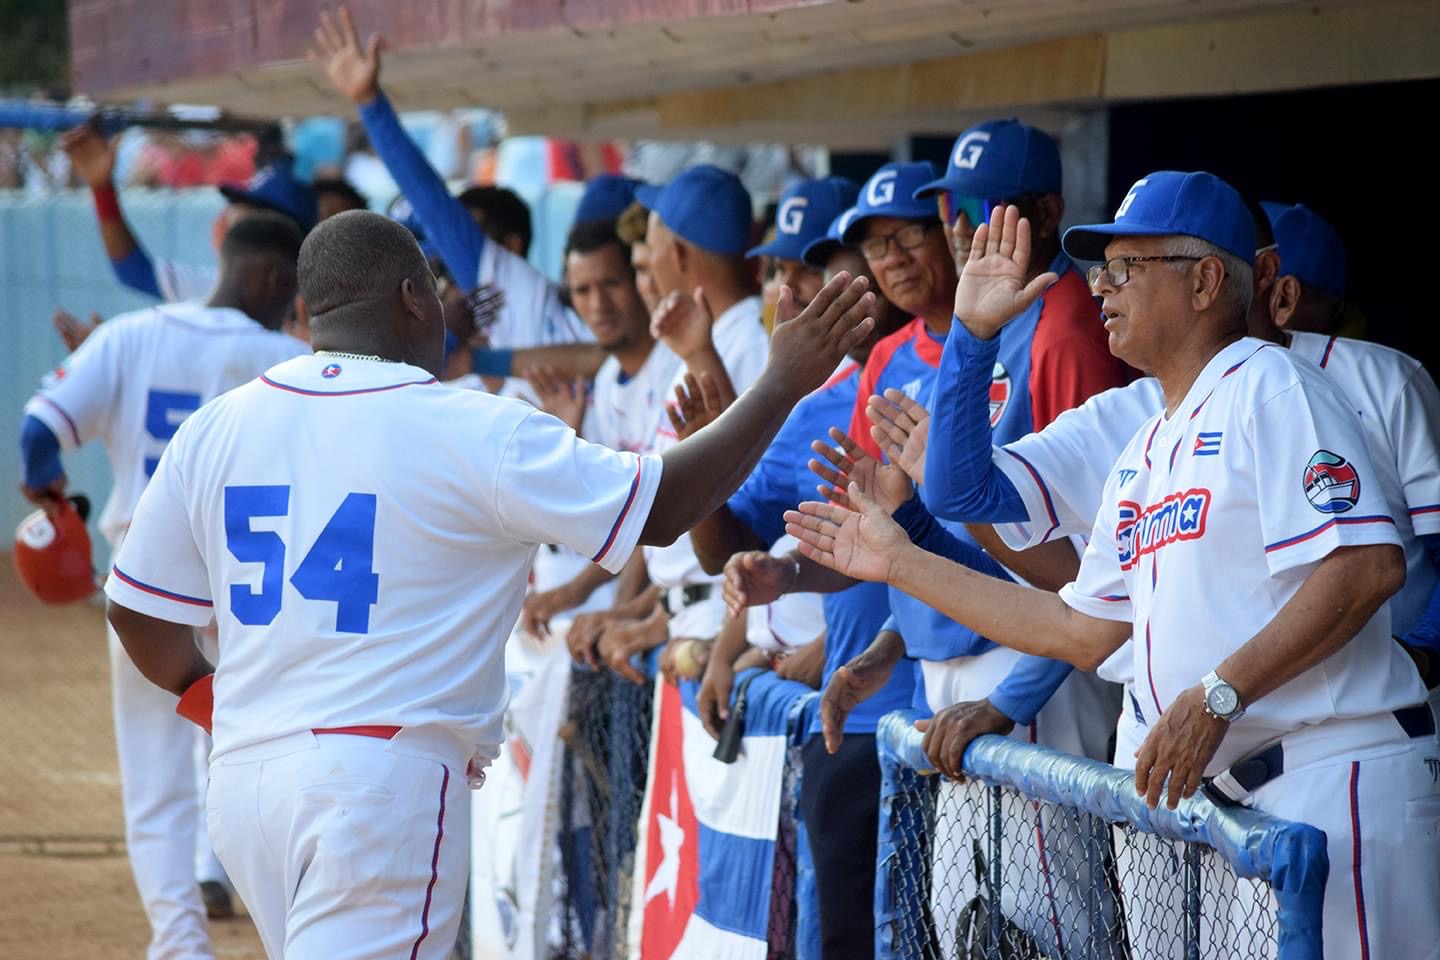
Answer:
top-left (888, 544), bottom-right (1130, 669)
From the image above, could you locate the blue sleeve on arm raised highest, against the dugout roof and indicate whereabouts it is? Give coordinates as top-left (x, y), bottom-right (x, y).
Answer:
top-left (352, 94), bottom-right (485, 294)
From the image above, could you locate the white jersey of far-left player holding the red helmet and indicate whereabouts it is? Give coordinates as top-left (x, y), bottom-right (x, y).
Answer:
top-left (24, 304), bottom-right (310, 544)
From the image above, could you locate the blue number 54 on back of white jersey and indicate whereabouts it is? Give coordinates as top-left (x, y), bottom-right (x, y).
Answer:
top-left (225, 485), bottom-right (380, 633)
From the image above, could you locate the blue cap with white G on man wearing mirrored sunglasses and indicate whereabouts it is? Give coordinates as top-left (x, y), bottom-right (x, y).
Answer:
top-left (914, 118), bottom-right (1061, 201)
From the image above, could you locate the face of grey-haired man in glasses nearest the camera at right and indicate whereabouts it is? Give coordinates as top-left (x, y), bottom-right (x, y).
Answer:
top-left (1094, 236), bottom-right (1195, 370)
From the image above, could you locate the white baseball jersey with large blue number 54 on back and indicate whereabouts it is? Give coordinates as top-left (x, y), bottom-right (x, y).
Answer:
top-left (105, 354), bottom-right (661, 760)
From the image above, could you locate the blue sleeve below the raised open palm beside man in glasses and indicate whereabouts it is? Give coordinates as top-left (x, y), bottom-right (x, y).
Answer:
top-left (920, 317), bottom-right (1027, 524)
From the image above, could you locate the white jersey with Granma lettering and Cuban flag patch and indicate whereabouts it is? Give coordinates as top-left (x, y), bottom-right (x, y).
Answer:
top-left (1060, 338), bottom-right (1426, 773)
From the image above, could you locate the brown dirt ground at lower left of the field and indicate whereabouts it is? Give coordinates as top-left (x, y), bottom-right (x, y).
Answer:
top-left (0, 554), bottom-right (265, 960)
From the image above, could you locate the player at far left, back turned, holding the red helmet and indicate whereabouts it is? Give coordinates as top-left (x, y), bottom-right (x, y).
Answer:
top-left (22, 213), bottom-right (307, 960)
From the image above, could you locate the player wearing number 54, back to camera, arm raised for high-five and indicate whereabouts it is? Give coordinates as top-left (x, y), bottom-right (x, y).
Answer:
top-left (107, 212), bottom-right (873, 960)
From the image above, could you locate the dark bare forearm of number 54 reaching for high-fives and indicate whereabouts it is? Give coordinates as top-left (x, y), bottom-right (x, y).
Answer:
top-left (641, 368), bottom-right (801, 544)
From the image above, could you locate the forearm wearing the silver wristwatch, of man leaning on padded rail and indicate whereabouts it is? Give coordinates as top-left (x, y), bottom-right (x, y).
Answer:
top-left (1215, 545), bottom-right (1405, 704)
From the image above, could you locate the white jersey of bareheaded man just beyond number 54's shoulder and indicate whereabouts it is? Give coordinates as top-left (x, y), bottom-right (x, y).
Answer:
top-left (585, 343), bottom-right (684, 453)
